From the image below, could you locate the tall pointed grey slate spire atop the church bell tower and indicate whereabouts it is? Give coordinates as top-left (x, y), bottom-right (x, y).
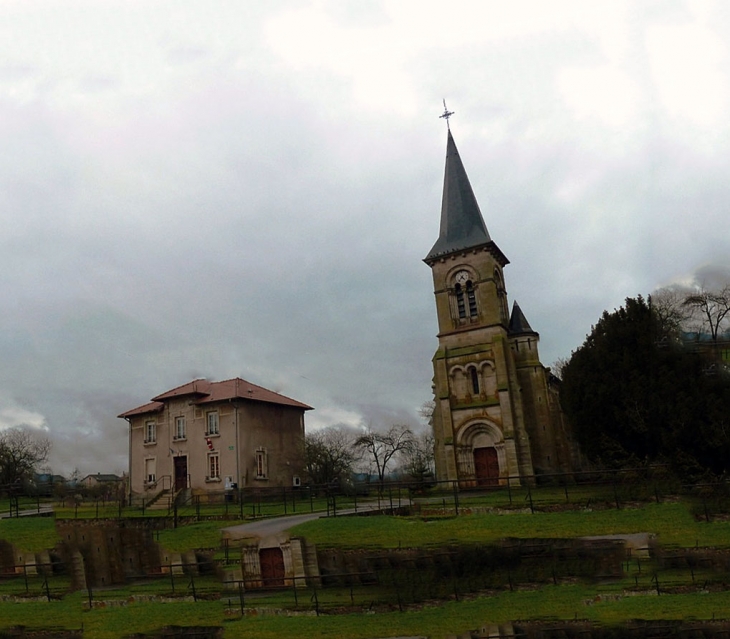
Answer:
top-left (426, 131), bottom-right (509, 264)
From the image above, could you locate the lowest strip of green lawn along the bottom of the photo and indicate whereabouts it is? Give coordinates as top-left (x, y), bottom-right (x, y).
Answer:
top-left (0, 586), bottom-right (730, 639)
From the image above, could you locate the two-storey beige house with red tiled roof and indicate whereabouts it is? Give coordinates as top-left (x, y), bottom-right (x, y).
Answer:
top-left (119, 378), bottom-right (311, 494)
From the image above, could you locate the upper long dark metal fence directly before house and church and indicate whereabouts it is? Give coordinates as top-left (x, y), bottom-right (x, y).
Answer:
top-left (7, 466), bottom-right (730, 525)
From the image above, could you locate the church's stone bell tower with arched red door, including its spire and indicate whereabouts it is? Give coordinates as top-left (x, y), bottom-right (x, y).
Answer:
top-left (424, 130), bottom-right (533, 486)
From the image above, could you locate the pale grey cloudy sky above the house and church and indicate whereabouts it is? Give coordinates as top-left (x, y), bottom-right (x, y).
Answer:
top-left (0, 0), bottom-right (730, 473)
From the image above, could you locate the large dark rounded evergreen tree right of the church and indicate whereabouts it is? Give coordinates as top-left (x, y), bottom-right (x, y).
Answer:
top-left (561, 297), bottom-right (730, 476)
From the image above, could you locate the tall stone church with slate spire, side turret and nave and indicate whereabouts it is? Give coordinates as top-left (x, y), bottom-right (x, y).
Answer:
top-left (424, 129), bottom-right (573, 487)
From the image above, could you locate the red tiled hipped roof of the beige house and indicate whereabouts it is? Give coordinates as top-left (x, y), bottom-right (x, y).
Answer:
top-left (119, 377), bottom-right (312, 418)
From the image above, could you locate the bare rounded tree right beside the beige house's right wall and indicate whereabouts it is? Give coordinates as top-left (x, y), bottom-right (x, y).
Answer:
top-left (304, 427), bottom-right (355, 484)
